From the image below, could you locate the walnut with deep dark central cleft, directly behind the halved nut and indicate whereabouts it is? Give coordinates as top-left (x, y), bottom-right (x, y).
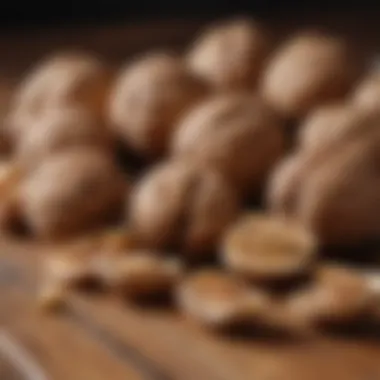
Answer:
top-left (130, 161), bottom-right (239, 255)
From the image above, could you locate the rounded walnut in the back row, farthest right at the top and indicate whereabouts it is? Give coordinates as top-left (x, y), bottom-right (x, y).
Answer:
top-left (262, 31), bottom-right (354, 117)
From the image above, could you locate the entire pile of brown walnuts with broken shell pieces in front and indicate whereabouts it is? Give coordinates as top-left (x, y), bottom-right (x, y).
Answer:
top-left (0, 19), bottom-right (380, 333)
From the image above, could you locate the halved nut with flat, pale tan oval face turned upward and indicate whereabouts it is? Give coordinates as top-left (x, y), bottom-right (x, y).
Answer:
top-left (222, 214), bottom-right (317, 280)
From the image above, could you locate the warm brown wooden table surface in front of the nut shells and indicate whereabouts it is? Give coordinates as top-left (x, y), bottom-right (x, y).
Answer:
top-left (0, 239), bottom-right (380, 380)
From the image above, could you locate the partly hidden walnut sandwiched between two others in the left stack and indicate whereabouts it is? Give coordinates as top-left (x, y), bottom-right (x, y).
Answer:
top-left (15, 107), bottom-right (111, 166)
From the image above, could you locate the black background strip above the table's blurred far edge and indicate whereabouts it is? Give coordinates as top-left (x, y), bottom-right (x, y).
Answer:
top-left (0, 0), bottom-right (372, 28)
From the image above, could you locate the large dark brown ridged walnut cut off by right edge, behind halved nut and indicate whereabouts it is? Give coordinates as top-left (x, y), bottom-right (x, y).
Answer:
top-left (268, 133), bottom-right (380, 245)
